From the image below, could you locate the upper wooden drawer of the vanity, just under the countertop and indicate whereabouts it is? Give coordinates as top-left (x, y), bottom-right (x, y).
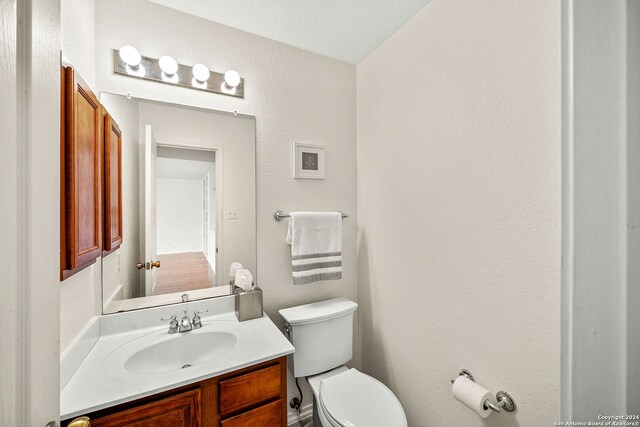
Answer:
top-left (220, 364), bottom-right (281, 418)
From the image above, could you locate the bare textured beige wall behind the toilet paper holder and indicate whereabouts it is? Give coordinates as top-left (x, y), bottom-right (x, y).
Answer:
top-left (357, 0), bottom-right (560, 427)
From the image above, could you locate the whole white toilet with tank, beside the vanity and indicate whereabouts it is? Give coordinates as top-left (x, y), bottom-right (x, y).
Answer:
top-left (280, 298), bottom-right (407, 427)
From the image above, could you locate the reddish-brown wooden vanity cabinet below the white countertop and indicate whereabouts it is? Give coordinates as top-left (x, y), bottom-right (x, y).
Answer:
top-left (62, 357), bottom-right (287, 427)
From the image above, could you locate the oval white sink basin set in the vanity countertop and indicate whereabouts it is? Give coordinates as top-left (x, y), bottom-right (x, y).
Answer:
top-left (124, 331), bottom-right (238, 375)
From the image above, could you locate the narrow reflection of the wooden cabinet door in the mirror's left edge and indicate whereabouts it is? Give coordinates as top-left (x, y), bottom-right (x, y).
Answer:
top-left (102, 111), bottom-right (122, 256)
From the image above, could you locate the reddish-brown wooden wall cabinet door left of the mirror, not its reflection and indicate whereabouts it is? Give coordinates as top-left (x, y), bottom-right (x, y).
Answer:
top-left (60, 67), bottom-right (102, 280)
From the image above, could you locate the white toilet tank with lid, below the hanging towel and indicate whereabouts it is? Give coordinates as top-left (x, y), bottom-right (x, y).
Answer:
top-left (279, 298), bottom-right (358, 377)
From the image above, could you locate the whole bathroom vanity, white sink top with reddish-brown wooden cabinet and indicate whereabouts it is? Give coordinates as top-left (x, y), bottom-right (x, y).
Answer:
top-left (61, 296), bottom-right (294, 427)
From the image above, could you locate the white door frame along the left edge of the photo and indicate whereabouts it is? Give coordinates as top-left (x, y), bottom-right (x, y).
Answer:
top-left (0, 0), bottom-right (61, 427)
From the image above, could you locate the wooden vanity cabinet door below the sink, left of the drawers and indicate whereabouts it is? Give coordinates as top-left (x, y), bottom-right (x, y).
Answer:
top-left (91, 388), bottom-right (200, 427)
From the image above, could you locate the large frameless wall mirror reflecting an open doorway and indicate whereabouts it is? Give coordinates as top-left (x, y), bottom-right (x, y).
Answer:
top-left (100, 93), bottom-right (257, 314)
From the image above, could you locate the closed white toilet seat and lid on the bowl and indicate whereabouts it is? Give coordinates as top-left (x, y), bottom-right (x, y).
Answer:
top-left (318, 369), bottom-right (407, 427)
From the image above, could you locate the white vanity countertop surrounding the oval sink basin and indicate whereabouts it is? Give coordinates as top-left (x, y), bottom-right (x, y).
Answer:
top-left (60, 312), bottom-right (294, 420)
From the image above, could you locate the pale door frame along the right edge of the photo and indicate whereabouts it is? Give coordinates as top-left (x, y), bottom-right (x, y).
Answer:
top-left (560, 0), bottom-right (640, 421)
